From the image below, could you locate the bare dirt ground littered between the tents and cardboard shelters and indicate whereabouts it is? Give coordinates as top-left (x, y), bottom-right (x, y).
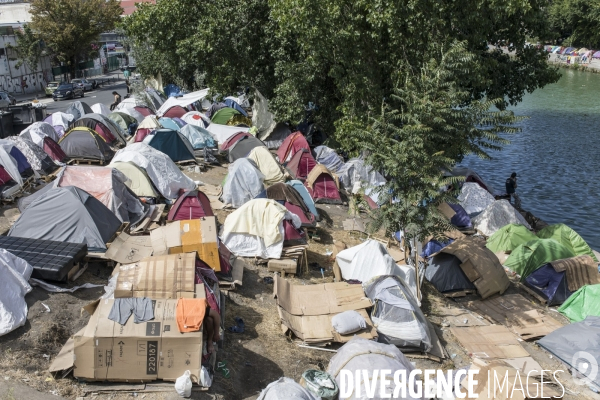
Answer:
top-left (0, 161), bottom-right (600, 400)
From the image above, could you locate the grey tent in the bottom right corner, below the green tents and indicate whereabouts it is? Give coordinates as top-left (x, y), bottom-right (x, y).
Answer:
top-left (537, 316), bottom-right (600, 387)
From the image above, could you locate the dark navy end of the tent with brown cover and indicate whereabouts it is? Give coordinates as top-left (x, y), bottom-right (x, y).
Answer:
top-left (425, 253), bottom-right (477, 293)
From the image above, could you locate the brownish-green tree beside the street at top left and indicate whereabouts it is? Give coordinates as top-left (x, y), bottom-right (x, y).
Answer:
top-left (29, 0), bottom-right (123, 77)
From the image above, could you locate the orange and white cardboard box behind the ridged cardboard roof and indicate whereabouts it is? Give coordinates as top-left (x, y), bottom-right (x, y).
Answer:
top-left (150, 217), bottom-right (221, 272)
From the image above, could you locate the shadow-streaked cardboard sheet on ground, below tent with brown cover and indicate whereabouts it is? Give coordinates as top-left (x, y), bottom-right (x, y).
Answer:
top-left (467, 294), bottom-right (562, 340)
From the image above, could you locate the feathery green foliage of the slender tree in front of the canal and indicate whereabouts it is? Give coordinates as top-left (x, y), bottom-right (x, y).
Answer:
top-left (349, 43), bottom-right (519, 239)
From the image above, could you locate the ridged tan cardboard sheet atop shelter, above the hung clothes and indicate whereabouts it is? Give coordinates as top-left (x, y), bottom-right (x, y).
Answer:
top-left (113, 253), bottom-right (196, 299)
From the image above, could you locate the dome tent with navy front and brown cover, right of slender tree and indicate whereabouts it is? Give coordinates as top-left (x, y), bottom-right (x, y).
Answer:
top-left (425, 236), bottom-right (510, 299)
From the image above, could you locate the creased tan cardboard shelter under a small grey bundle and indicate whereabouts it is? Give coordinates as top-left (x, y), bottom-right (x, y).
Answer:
top-left (274, 276), bottom-right (377, 344)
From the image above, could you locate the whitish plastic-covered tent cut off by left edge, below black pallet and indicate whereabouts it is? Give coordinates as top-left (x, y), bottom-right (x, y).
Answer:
top-left (0, 249), bottom-right (33, 336)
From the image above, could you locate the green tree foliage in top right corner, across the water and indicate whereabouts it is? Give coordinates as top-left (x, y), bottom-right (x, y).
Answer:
top-left (546, 0), bottom-right (600, 48)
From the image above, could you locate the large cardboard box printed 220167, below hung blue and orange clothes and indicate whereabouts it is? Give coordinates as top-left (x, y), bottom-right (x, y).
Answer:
top-left (73, 300), bottom-right (202, 382)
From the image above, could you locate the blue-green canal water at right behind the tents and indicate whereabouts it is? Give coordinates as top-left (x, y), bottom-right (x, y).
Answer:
top-left (462, 70), bottom-right (600, 250)
